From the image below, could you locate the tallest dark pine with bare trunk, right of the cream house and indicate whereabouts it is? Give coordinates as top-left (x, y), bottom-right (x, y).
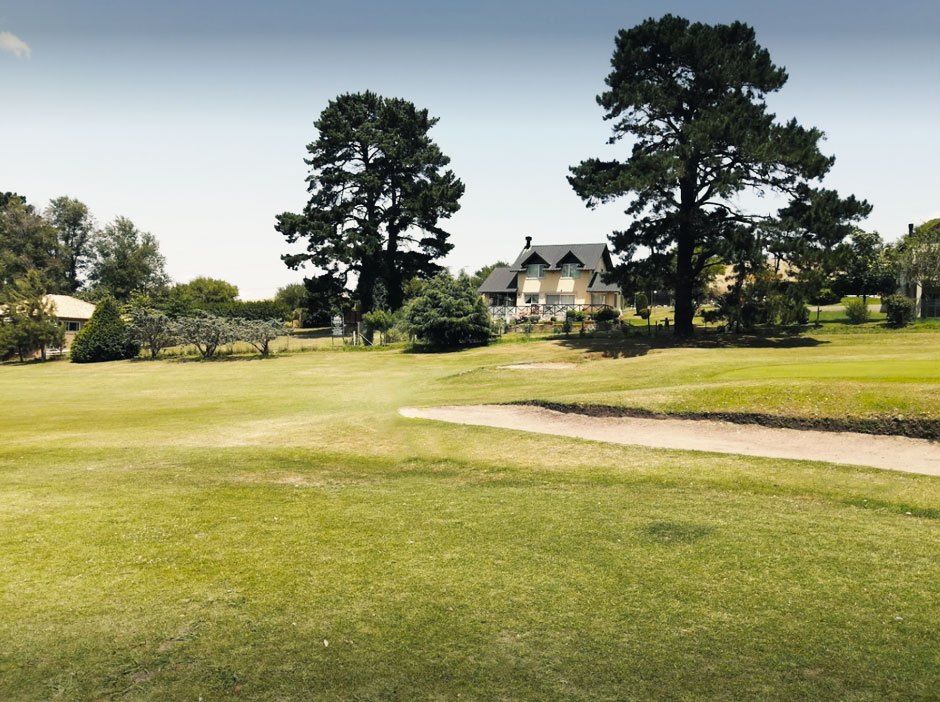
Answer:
top-left (569, 15), bottom-right (871, 335)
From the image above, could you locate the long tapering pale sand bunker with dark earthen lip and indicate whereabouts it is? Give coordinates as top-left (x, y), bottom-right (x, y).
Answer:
top-left (399, 405), bottom-right (940, 475)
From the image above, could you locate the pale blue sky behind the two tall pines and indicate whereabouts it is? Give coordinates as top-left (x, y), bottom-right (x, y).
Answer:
top-left (0, 0), bottom-right (940, 299)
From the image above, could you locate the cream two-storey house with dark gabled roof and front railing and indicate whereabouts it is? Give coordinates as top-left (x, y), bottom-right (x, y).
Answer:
top-left (478, 236), bottom-right (623, 318)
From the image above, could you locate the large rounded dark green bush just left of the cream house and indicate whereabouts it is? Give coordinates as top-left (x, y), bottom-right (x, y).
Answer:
top-left (405, 271), bottom-right (492, 348)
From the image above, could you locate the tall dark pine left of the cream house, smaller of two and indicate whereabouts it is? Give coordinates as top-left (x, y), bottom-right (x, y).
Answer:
top-left (276, 92), bottom-right (464, 312)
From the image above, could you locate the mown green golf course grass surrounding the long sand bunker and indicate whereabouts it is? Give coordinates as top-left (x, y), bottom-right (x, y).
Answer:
top-left (0, 328), bottom-right (940, 702)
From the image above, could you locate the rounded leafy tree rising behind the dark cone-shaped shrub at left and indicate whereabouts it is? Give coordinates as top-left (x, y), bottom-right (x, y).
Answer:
top-left (89, 217), bottom-right (169, 302)
